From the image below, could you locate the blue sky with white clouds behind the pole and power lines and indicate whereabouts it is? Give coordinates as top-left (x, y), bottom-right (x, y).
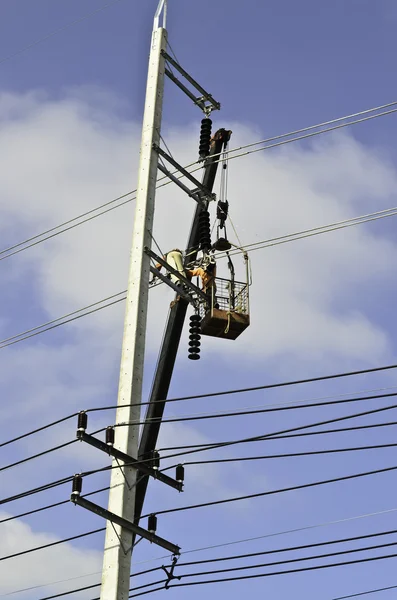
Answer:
top-left (0, 0), bottom-right (397, 600)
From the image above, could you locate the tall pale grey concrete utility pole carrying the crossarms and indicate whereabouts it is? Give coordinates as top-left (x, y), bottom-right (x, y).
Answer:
top-left (101, 0), bottom-right (167, 600)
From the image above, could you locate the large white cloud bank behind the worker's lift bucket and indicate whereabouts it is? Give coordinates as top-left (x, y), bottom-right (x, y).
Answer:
top-left (0, 91), bottom-right (396, 376)
